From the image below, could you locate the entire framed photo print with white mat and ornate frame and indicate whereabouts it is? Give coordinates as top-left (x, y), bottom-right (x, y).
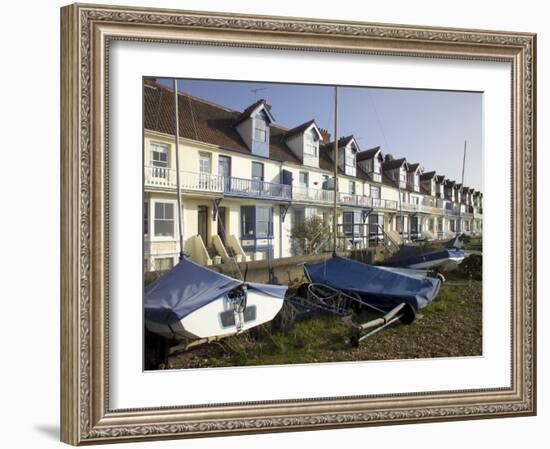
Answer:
top-left (61, 5), bottom-right (536, 444)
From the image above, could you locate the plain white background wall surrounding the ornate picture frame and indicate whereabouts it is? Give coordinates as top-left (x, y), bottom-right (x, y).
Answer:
top-left (0, 0), bottom-right (550, 449)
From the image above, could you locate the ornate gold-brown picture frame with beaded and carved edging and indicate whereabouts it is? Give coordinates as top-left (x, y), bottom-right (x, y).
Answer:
top-left (61, 4), bottom-right (536, 445)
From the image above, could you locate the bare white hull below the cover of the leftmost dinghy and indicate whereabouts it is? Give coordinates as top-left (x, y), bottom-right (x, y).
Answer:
top-left (145, 290), bottom-right (284, 340)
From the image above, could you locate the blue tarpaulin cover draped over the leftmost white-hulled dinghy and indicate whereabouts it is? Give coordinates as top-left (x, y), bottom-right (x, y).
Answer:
top-left (144, 257), bottom-right (287, 324)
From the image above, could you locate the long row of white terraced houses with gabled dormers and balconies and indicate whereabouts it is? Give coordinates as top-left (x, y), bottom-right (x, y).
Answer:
top-left (143, 80), bottom-right (483, 271)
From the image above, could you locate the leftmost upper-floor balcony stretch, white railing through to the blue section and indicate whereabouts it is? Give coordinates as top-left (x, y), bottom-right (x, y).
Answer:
top-left (145, 167), bottom-right (291, 201)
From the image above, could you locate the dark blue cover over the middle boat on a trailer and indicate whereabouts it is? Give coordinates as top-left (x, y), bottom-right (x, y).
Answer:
top-left (304, 256), bottom-right (441, 310)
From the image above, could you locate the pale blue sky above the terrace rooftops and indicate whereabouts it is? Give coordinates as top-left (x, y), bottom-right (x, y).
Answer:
top-left (158, 79), bottom-right (483, 191)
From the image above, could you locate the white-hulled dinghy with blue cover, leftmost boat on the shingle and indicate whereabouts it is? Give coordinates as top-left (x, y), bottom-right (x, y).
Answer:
top-left (144, 257), bottom-right (287, 340)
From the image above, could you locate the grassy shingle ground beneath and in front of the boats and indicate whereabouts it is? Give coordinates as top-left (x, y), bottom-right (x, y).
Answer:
top-left (166, 280), bottom-right (482, 369)
